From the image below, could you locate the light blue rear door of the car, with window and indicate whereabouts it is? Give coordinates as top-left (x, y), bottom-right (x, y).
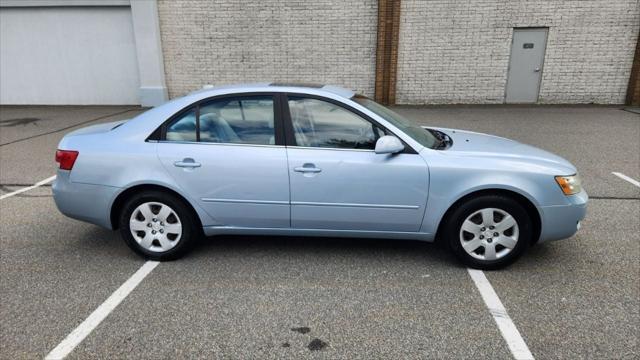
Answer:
top-left (157, 94), bottom-right (290, 228)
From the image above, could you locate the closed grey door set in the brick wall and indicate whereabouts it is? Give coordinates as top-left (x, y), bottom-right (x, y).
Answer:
top-left (506, 28), bottom-right (548, 103)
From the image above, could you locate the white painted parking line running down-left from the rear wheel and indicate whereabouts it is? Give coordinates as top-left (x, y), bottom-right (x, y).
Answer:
top-left (45, 261), bottom-right (159, 360)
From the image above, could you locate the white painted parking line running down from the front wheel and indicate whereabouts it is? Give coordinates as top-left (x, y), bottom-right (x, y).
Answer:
top-left (467, 269), bottom-right (533, 360)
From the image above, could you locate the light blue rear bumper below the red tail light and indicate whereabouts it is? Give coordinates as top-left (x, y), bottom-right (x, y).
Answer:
top-left (52, 170), bottom-right (120, 229)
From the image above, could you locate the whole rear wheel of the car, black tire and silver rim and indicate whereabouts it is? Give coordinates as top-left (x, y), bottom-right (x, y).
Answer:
top-left (120, 191), bottom-right (199, 261)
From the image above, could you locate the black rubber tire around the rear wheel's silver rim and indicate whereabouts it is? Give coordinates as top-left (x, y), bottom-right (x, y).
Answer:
top-left (119, 190), bottom-right (201, 261)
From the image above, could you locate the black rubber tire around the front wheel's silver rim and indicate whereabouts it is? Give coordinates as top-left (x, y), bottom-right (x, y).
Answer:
top-left (442, 195), bottom-right (533, 270)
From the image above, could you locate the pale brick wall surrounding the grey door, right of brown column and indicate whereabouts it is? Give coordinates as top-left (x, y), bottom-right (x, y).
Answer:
top-left (396, 0), bottom-right (640, 104)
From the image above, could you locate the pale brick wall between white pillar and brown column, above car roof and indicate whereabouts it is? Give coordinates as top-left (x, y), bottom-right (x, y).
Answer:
top-left (158, 0), bottom-right (377, 97)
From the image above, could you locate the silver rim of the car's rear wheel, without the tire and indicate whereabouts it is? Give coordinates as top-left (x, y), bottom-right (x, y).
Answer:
top-left (129, 202), bottom-right (182, 252)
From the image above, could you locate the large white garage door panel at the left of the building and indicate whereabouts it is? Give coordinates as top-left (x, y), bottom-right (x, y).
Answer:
top-left (0, 7), bottom-right (140, 104)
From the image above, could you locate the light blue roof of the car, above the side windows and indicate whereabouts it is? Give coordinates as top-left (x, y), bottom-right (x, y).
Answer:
top-left (191, 82), bottom-right (356, 99)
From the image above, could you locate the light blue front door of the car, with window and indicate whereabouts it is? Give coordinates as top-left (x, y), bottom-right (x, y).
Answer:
top-left (287, 96), bottom-right (429, 232)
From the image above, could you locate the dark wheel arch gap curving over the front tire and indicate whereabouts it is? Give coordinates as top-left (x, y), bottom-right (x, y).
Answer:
top-left (435, 188), bottom-right (542, 244)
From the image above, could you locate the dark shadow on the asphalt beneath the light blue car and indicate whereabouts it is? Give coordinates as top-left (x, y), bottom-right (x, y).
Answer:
top-left (74, 226), bottom-right (572, 270)
